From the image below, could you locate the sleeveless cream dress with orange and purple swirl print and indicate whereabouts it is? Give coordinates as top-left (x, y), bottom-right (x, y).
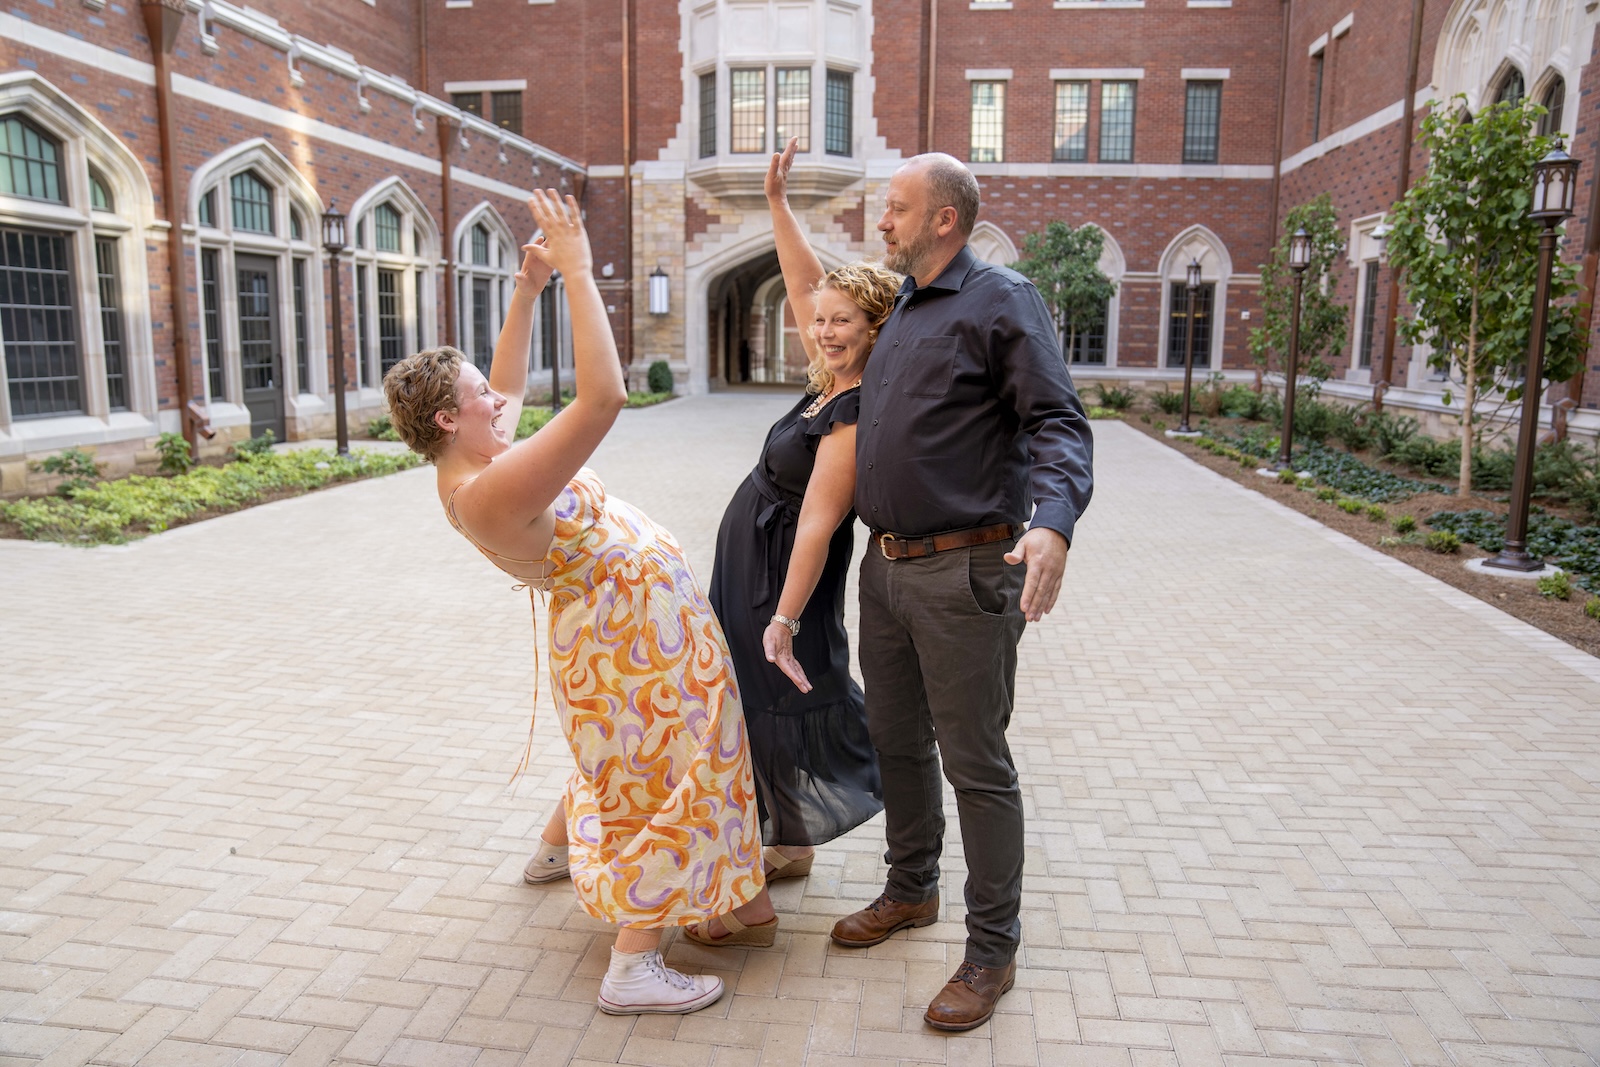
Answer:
top-left (450, 469), bottom-right (763, 926)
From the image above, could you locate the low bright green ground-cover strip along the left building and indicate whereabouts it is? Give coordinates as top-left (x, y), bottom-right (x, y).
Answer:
top-left (0, 438), bottom-right (421, 544)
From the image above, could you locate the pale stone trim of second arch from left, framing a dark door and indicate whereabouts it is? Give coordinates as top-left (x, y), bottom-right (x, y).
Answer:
top-left (184, 138), bottom-right (331, 409)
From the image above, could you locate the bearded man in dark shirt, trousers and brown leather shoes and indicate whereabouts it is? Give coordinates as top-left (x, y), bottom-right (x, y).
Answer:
top-left (834, 154), bottom-right (1093, 1030)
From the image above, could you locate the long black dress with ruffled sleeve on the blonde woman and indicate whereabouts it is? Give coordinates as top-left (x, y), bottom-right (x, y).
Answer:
top-left (710, 389), bottom-right (883, 846)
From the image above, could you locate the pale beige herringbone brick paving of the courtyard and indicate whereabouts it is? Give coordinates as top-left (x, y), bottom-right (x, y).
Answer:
top-left (0, 394), bottom-right (1600, 1067)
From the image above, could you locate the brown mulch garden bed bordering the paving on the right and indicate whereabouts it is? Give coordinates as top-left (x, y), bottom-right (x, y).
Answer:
top-left (1123, 413), bottom-right (1600, 657)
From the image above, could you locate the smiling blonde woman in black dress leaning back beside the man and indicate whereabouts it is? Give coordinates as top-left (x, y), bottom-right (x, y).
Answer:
top-left (685, 141), bottom-right (901, 947)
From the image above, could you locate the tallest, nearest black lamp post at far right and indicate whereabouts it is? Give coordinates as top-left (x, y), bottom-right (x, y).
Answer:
top-left (1483, 142), bottom-right (1578, 573)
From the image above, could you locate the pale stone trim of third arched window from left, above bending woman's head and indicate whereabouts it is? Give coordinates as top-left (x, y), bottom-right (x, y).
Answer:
top-left (341, 178), bottom-right (441, 396)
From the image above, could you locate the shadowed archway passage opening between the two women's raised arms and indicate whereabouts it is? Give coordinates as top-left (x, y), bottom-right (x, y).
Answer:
top-left (706, 250), bottom-right (805, 389)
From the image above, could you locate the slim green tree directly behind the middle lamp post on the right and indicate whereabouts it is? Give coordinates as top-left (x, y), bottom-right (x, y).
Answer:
top-left (1250, 194), bottom-right (1349, 392)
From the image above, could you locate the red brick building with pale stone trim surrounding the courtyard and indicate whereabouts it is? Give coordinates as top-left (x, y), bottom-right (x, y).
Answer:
top-left (0, 0), bottom-right (1600, 491)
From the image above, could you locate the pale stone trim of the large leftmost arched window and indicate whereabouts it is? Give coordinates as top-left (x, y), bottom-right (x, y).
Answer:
top-left (0, 70), bottom-right (157, 438)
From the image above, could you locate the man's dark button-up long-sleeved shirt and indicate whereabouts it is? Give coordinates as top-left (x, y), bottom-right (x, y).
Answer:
top-left (856, 248), bottom-right (1094, 542)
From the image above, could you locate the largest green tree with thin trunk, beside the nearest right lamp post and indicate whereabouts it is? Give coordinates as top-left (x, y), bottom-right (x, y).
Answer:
top-left (1389, 96), bottom-right (1582, 494)
